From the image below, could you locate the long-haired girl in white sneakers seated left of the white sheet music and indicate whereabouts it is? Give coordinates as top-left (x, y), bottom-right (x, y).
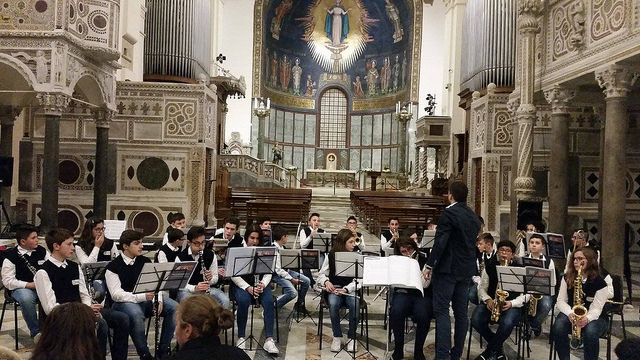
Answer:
top-left (318, 229), bottom-right (360, 352)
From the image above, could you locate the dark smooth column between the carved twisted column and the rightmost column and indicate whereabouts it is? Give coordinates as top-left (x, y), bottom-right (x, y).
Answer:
top-left (544, 86), bottom-right (575, 236)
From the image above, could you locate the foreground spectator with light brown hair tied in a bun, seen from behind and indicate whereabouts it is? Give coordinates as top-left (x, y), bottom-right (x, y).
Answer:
top-left (173, 295), bottom-right (251, 360)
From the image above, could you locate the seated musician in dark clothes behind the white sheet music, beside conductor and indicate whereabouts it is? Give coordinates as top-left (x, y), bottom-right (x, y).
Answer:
top-left (389, 238), bottom-right (433, 360)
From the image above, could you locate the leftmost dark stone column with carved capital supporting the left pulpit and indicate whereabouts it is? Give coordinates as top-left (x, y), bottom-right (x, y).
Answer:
top-left (36, 93), bottom-right (70, 232)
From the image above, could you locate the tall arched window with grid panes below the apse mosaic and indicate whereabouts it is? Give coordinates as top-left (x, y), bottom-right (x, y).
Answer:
top-left (320, 89), bottom-right (347, 149)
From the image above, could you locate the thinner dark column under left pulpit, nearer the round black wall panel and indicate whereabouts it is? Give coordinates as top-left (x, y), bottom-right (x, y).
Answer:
top-left (93, 109), bottom-right (113, 219)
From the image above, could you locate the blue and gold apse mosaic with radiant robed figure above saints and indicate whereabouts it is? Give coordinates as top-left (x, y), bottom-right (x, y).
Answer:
top-left (262, 0), bottom-right (413, 104)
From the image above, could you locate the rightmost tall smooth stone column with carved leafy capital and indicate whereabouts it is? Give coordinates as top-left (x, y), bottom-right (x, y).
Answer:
top-left (595, 65), bottom-right (640, 275)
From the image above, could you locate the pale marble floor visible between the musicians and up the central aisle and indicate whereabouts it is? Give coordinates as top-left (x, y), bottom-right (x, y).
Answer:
top-left (0, 188), bottom-right (640, 360)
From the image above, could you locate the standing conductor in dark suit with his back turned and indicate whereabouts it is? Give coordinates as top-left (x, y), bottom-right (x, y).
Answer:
top-left (424, 181), bottom-right (480, 360)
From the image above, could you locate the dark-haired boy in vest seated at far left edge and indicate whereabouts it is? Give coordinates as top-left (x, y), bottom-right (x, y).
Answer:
top-left (2, 225), bottom-right (48, 342)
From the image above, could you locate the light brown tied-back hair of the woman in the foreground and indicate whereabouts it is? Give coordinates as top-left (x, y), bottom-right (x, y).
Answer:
top-left (176, 294), bottom-right (233, 337)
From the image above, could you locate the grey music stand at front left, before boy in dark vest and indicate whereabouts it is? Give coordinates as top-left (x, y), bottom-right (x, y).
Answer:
top-left (133, 261), bottom-right (196, 359)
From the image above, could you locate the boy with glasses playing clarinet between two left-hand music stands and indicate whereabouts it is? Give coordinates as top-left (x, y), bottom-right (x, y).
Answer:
top-left (176, 226), bottom-right (231, 309)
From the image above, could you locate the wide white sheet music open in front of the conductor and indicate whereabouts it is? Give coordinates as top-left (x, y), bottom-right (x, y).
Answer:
top-left (362, 255), bottom-right (424, 295)
